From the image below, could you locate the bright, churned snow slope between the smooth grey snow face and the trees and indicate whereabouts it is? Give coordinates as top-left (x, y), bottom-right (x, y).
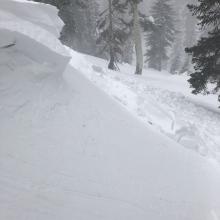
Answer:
top-left (69, 50), bottom-right (220, 162)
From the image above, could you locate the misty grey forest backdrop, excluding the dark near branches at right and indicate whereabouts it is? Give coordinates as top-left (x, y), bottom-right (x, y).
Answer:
top-left (30, 0), bottom-right (190, 74)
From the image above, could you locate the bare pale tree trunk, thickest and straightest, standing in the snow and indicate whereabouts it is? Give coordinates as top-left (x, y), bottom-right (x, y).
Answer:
top-left (133, 2), bottom-right (143, 75)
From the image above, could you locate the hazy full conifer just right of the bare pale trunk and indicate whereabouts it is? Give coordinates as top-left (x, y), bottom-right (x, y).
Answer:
top-left (145, 0), bottom-right (176, 71)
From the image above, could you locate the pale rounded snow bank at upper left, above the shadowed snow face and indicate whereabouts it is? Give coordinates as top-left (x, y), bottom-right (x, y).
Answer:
top-left (0, 0), bottom-right (68, 56)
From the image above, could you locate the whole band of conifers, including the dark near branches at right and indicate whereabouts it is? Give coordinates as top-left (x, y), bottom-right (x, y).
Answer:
top-left (30, 0), bottom-right (220, 104)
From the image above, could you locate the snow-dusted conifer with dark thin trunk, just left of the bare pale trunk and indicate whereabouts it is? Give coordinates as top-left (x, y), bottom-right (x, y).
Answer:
top-left (97, 0), bottom-right (130, 70)
